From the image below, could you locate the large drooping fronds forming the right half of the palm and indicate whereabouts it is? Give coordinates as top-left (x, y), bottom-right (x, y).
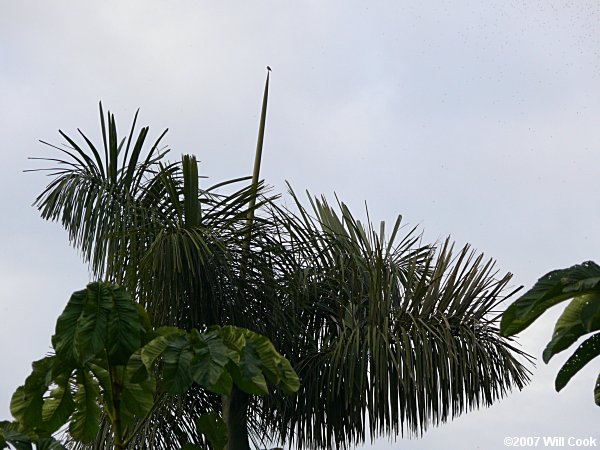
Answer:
top-left (267, 194), bottom-right (528, 448)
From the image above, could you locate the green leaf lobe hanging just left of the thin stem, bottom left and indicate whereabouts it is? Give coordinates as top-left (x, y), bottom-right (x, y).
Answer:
top-left (69, 371), bottom-right (100, 444)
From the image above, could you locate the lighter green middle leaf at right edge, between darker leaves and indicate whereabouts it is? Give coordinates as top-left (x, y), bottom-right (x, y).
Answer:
top-left (543, 293), bottom-right (600, 363)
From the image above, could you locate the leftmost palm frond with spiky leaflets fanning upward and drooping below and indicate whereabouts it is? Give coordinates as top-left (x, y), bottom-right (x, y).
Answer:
top-left (34, 105), bottom-right (168, 278)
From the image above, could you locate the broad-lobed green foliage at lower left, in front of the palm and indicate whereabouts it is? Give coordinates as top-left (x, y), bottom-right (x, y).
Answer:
top-left (0, 282), bottom-right (298, 450)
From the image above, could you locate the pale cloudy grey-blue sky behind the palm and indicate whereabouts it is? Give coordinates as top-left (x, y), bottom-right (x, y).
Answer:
top-left (0, 0), bottom-right (600, 450)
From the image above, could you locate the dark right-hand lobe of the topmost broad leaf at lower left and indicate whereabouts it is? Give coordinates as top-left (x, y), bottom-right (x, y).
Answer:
top-left (106, 286), bottom-right (145, 365)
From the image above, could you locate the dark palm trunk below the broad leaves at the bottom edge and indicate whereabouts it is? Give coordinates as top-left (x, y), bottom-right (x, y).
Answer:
top-left (222, 386), bottom-right (250, 450)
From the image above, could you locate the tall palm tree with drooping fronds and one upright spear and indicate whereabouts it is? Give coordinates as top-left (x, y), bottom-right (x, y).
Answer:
top-left (29, 74), bottom-right (528, 450)
